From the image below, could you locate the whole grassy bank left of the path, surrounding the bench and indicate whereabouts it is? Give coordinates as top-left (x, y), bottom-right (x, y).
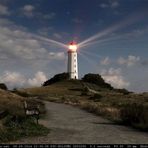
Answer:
top-left (0, 89), bottom-right (49, 143)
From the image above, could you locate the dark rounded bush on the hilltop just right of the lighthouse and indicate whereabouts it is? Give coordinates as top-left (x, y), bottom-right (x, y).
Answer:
top-left (82, 73), bottom-right (113, 89)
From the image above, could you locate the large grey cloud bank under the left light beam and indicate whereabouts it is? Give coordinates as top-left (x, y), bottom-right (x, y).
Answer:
top-left (0, 18), bottom-right (66, 75)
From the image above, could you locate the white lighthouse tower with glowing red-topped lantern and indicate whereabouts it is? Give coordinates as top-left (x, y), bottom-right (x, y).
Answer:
top-left (68, 42), bottom-right (78, 79)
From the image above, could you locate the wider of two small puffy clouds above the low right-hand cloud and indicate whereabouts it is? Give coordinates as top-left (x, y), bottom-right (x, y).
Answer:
top-left (117, 55), bottom-right (140, 67)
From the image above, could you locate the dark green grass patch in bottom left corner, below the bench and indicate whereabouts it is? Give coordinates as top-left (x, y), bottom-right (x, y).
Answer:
top-left (0, 116), bottom-right (49, 143)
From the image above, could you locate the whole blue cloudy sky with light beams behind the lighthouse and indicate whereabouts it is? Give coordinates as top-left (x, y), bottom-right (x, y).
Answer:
top-left (0, 0), bottom-right (148, 92)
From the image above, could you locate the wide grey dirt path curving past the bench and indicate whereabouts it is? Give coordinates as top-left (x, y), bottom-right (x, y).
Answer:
top-left (10, 102), bottom-right (148, 144)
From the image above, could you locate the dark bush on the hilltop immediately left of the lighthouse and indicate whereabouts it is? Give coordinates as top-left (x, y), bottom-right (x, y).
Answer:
top-left (42, 73), bottom-right (69, 86)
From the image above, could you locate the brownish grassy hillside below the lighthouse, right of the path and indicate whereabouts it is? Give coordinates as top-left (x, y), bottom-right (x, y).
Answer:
top-left (17, 80), bottom-right (148, 131)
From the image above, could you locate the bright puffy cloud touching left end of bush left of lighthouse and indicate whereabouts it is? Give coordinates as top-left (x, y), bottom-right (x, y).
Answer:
top-left (28, 71), bottom-right (47, 86)
